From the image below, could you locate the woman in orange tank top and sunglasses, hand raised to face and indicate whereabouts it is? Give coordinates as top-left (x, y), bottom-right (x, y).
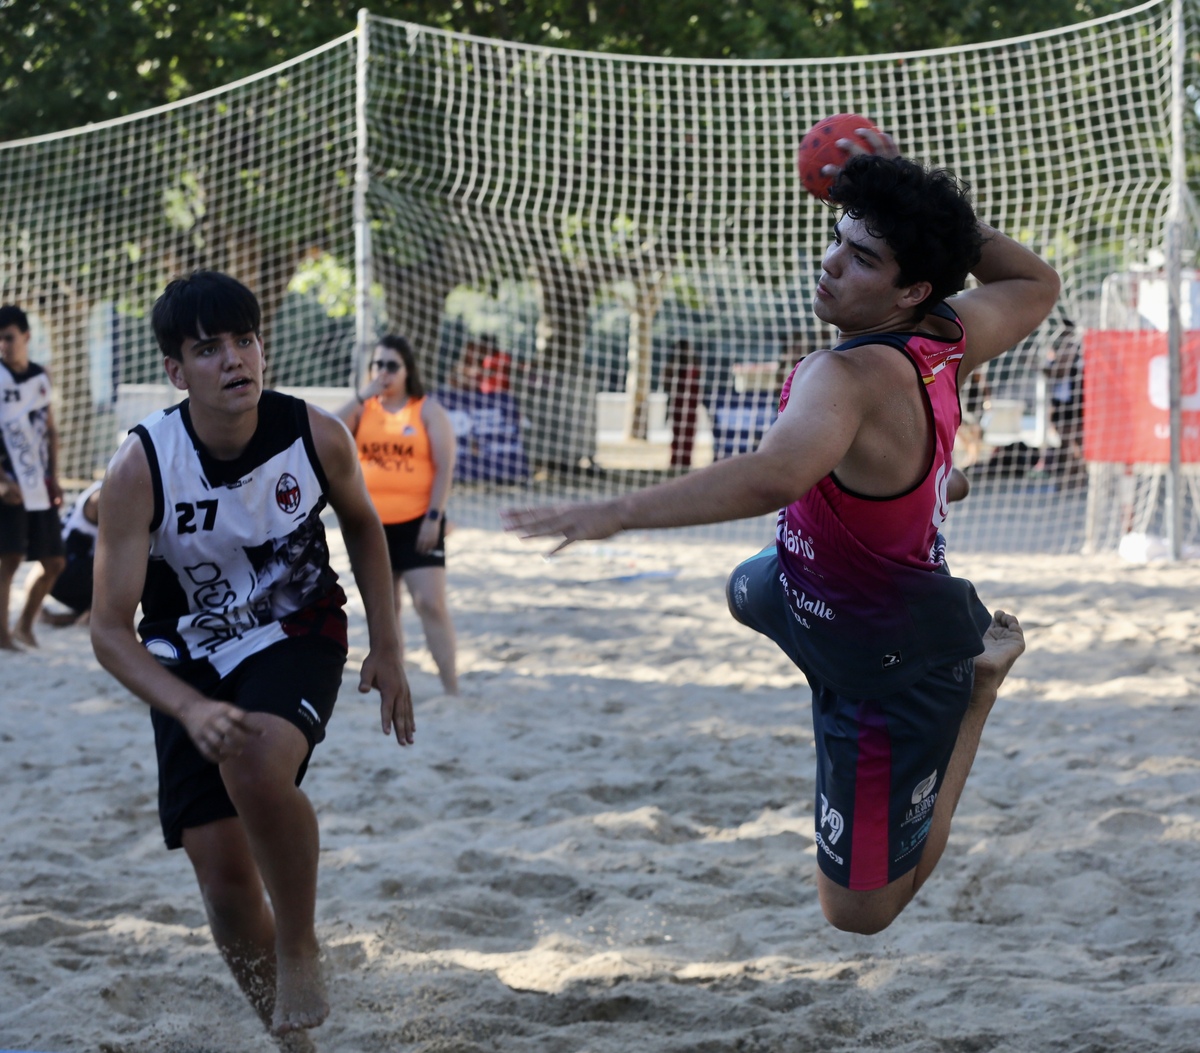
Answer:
top-left (338, 336), bottom-right (458, 694)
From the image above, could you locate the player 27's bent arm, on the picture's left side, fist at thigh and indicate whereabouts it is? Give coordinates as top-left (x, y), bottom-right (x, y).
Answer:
top-left (90, 435), bottom-right (259, 764)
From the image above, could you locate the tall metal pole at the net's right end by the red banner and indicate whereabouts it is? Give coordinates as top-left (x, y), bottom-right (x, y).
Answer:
top-left (1165, 0), bottom-right (1187, 561)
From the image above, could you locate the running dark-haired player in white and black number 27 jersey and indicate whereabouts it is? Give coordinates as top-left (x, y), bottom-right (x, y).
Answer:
top-left (91, 271), bottom-right (414, 1051)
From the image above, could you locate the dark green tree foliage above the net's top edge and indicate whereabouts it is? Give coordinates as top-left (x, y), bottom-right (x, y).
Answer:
top-left (0, 0), bottom-right (1134, 140)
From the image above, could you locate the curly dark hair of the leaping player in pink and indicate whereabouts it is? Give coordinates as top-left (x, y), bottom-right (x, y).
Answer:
top-left (829, 154), bottom-right (983, 318)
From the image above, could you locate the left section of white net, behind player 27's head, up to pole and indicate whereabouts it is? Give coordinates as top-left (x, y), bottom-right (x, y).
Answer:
top-left (0, 38), bottom-right (354, 477)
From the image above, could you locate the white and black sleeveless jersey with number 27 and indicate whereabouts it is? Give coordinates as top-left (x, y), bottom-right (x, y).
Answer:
top-left (133, 391), bottom-right (346, 679)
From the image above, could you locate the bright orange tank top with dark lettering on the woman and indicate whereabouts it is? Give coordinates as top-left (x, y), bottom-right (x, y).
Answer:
top-left (354, 398), bottom-right (434, 523)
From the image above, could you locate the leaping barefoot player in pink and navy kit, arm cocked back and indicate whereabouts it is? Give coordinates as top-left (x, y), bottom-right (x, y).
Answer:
top-left (505, 132), bottom-right (1060, 933)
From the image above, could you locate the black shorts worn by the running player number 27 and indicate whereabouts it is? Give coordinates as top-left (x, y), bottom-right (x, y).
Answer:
top-left (150, 636), bottom-right (346, 848)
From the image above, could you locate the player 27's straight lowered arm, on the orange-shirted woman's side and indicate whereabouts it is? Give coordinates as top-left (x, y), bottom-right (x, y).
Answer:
top-left (308, 405), bottom-right (416, 746)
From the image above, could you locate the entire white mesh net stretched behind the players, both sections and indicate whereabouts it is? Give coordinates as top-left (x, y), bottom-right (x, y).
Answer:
top-left (0, 2), bottom-right (1200, 552)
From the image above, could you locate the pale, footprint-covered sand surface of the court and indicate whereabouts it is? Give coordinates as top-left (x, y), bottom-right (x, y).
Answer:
top-left (0, 529), bottom-right (1200, 1053)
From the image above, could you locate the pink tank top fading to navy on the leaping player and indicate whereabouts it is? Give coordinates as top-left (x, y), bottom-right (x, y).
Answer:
top-left (775, 303), bottom-right (990, 697)
